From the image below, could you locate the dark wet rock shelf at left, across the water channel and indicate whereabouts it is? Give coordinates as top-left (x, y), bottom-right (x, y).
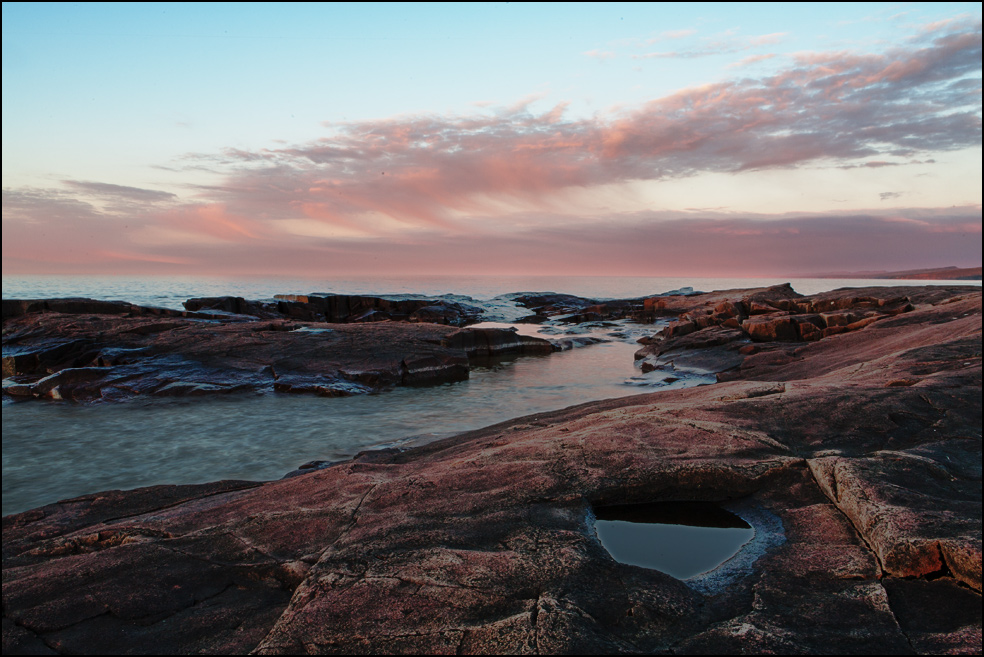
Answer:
top-left (3, 299), bottom-right (553, 401)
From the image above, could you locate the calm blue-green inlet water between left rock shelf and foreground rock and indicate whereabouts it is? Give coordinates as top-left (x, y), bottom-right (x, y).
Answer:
top-left (3, 327), bottom-right (700, 515)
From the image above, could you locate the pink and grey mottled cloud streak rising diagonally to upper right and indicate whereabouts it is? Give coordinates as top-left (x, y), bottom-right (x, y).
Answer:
top-left (181, 18), bottom-right (981, 232)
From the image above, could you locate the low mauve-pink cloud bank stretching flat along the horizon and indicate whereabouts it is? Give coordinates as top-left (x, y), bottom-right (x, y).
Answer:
top-left (2, 182), bottom-right (981, 277)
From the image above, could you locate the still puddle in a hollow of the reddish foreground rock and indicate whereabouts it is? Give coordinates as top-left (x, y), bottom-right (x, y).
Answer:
top-left (594, 502), bottom-right (755, 579)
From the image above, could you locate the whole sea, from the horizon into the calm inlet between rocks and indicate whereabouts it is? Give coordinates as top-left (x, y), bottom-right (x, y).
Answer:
top-left (2, 275), bottom-right (981, 515)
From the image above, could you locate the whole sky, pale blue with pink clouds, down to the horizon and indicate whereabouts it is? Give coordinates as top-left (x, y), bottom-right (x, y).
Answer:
top-left (2, 3), bottom-right (981, 277)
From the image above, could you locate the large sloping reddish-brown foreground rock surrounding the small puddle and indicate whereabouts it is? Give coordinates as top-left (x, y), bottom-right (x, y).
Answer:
top-left (3, 288), bottom-right (981, 654)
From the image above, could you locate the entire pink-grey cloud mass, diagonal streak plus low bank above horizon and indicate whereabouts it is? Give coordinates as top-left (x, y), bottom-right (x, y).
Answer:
top-left (3, 24), bottom-right (981, 275)
